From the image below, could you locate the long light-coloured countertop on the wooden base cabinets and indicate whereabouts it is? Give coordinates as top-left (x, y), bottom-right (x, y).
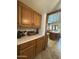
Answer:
top-left (17, 34), bottom-right (44, 45)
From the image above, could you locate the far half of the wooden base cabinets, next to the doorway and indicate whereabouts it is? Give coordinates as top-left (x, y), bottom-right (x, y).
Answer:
top-left (36, 36), bottom-right (48, 55)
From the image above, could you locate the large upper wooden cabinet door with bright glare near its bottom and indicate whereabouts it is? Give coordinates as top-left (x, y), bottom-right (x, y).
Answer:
top-left (21, 6), bottom-right (33, 28)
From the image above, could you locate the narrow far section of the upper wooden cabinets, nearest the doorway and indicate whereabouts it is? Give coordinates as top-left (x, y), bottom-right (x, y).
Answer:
top-left (33, 12), bottom-right (41, 28)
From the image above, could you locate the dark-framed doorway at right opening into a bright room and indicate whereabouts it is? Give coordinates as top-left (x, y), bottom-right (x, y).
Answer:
top-left (46, 10), bottom-right (61, 57)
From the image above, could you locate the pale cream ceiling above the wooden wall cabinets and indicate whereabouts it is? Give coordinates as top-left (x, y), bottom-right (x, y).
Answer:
top-left (19, 0), bottom-right (60, 14)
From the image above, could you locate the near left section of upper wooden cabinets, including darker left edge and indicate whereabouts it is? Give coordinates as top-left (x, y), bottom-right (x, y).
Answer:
top-left (17, 1), bottom-right (33, 28)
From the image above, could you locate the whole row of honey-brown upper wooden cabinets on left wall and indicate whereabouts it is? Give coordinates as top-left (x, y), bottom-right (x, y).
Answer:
top-left (17, 2), bottom-right (41, 28)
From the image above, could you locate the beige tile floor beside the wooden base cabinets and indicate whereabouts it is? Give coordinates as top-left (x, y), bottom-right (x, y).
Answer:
top-left (35, 39), bottom-right (61, 59)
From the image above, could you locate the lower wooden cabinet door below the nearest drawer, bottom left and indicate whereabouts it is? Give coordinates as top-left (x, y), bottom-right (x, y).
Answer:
top-left (20, 46), bottom-right (35, 59)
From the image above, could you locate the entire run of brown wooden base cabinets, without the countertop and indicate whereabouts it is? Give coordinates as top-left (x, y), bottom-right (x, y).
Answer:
top-left (17, 36), bottom-right (47, 59)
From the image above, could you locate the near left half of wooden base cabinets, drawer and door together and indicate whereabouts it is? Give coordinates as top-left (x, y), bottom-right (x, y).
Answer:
top-left (17, 40), bottom-right (35, 59)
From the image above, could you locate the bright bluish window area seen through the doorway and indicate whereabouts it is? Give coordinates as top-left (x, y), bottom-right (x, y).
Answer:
top-left (47, 11), bottom-right (61, 31)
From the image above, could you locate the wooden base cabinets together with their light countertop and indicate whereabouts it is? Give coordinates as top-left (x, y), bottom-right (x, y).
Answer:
top-left (17, 34), bottom-right (48, 59)
